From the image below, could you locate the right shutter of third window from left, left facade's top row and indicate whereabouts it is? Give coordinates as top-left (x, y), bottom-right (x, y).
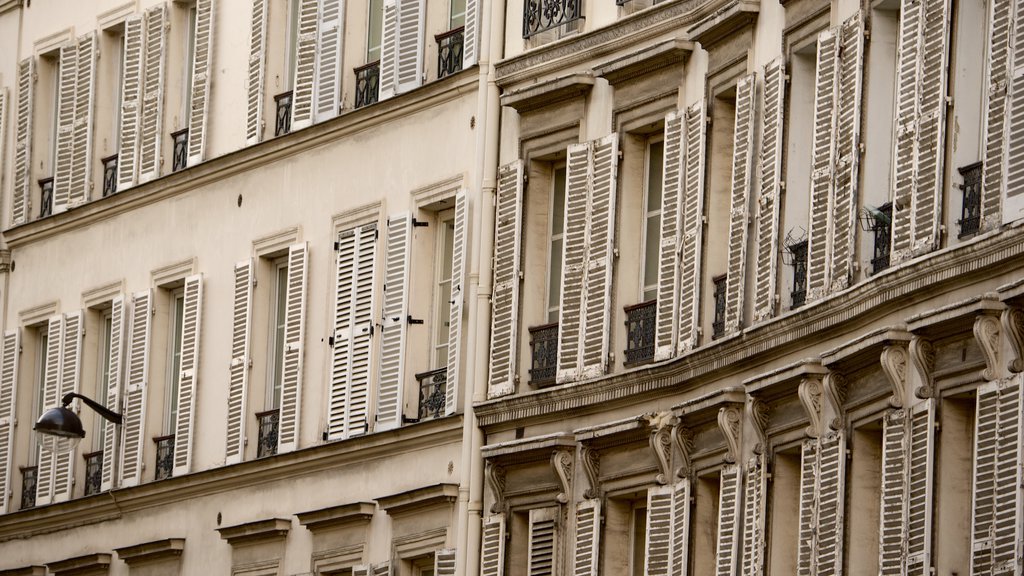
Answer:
top-left (188, 0), bottom-right (214, 166)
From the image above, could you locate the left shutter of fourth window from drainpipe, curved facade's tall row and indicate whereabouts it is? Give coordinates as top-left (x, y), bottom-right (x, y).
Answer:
top-left (754, 58), bottom-right (785, 321)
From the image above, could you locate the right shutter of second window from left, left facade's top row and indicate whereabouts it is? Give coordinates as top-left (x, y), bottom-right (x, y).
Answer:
top-left (118, 15), bottom-right (144, 190)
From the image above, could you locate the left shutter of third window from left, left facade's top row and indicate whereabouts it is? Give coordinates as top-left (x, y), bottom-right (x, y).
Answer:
top-left (138, 4), bottom-right (165, 182)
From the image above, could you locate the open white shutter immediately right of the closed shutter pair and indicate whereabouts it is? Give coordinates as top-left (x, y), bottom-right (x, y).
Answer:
top-left (375, 212), bottom-right (413, 430)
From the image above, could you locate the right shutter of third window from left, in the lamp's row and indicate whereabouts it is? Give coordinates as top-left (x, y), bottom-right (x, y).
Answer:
top-left (172, 275), bottom-right (203, 477)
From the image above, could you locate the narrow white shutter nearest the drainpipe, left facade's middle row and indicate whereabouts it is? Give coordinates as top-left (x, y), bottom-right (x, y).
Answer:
top-left (444, 191), bottom-right (470, 414)
